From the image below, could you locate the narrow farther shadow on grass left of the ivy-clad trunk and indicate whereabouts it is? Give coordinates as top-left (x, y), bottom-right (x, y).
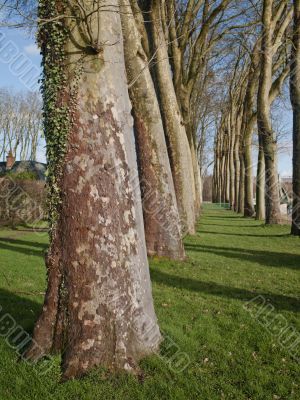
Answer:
top-left (0, 238), bottom-right (48, 257)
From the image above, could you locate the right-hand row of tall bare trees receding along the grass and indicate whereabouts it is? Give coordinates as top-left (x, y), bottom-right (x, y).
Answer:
top-left (213, 0), bottom-right (300, 235)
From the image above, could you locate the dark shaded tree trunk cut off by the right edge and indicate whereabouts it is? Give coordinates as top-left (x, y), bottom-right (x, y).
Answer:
top-left (290, 0), bottom-right (300, 236)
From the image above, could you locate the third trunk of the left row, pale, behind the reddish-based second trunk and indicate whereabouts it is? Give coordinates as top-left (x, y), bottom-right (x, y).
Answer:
top-left (146, 0), bottom-right (196, 234)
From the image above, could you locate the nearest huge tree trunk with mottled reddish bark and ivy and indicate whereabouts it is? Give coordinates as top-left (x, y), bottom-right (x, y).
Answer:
top-left (27, 0), bottom-right (160, 378)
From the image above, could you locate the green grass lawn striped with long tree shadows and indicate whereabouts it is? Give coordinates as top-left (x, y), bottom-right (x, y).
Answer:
top-left (0, 206), bottom-right (300, 400)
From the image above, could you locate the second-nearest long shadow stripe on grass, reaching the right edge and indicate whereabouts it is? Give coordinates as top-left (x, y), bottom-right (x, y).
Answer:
top-left (185, 242), bottom-right (300, 271)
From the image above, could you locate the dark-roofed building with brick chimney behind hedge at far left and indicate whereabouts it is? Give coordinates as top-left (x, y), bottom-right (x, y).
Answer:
top-left (0, 151), bottom-right (47, 181)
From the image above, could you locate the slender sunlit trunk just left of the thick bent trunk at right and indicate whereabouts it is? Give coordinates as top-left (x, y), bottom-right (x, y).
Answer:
top-left (256, 138), bottom-right (266, 220)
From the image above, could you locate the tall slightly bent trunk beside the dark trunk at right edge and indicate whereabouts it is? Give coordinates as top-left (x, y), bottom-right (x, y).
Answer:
top-left (257, 0), bottom-right (281, 224)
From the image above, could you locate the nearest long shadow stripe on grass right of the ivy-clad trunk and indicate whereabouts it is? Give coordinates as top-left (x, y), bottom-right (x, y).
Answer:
top-left (151, 268), bottom-right (300, 312)
